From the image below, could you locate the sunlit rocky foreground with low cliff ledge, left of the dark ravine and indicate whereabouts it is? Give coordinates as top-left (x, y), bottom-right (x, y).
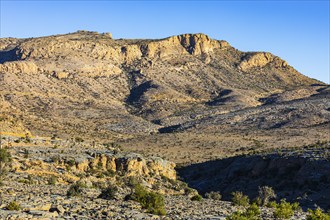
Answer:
top-left (0, 137), bottom-right (320, 219)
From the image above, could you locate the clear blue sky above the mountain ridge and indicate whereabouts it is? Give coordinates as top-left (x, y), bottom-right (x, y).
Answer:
top-left (0, 0), bottom-right (329, 83)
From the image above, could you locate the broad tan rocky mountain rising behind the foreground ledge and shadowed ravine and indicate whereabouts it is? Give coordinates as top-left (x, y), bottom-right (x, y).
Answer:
top-left (0, 31), bottom-right (330, 162)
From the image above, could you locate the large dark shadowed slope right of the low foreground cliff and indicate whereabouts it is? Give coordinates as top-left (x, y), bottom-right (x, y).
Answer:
top-left (178, 150), bottom-right (330, 210)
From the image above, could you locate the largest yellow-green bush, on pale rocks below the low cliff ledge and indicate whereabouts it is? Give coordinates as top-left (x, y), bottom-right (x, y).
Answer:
top-left (129, 184), bottom-right (166, 215)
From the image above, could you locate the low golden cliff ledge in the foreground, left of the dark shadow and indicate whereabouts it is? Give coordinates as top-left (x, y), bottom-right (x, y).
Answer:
top-left (12, 152), bottom-right (176, 180)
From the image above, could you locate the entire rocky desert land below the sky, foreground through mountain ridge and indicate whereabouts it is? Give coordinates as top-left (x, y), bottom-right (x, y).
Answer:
top-left (0, 31), bottom-right (330, 219)
